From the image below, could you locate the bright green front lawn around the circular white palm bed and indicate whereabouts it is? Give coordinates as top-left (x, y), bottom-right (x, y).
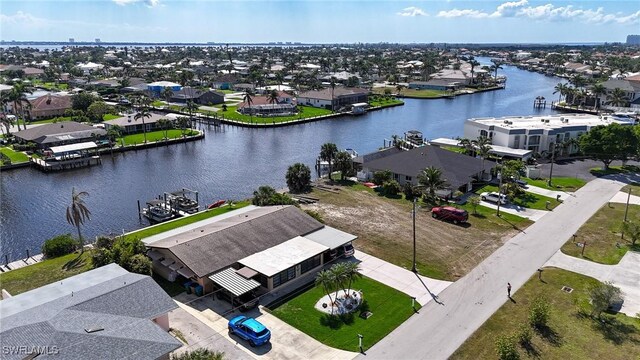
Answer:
top-left (272, 277), bottom-right (420, 351)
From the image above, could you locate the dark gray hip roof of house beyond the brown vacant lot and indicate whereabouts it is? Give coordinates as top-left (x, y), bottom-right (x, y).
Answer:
top-left (363, 145), bottom-right (495, 189)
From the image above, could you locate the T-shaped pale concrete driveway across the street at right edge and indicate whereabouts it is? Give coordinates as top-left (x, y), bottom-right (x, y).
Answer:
top-left (544, 250), bottom-right (640, 317)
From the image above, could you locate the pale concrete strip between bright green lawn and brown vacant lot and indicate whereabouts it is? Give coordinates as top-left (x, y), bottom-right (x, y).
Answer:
top-left (354, 250), bottom-right (452, 306)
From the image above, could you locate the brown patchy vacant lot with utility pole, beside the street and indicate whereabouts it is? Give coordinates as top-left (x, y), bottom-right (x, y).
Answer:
top-left (303, 184), bottom-right (531, 280)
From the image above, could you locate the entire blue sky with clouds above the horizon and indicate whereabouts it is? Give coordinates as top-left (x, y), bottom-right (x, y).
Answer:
top-left (0, 0), bottom-right (640, 43)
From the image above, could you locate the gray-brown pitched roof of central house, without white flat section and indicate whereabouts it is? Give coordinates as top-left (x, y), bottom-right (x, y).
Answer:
top-left (148, 206), bottom-right (323, 277)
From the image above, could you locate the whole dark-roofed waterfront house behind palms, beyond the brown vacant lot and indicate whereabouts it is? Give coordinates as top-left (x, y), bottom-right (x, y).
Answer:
top-left (354, 145), bottom-right (495, 196)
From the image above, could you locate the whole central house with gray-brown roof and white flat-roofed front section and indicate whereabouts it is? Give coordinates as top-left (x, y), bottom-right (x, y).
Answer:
top-left (143, 206), bottom-right (356, 296)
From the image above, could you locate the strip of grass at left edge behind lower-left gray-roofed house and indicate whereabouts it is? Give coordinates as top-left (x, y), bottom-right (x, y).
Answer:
top-left (0, 251), bottom-right (93, 295)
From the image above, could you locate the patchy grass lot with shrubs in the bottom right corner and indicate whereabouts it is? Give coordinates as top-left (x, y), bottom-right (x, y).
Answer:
top-left (450, 268), bottom-right (640, 360)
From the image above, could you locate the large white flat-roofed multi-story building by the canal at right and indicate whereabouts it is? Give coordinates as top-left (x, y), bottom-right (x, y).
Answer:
top-left (464, 114), bottom-right (635, 155)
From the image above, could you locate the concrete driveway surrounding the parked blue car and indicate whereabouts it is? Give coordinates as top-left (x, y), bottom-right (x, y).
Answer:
top-left (174, 294), bottom-right (358, 360)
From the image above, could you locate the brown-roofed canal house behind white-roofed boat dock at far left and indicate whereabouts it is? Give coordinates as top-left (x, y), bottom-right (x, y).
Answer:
top-left (13, 121), bottom-right (107, 149)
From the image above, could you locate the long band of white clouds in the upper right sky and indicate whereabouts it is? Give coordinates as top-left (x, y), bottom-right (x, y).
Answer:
top-left (437, 0), bottom-right (640, 25)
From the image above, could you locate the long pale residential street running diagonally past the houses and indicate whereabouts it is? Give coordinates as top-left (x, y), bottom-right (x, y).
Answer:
top-left (361, 175), bottom-right (638, 359)
